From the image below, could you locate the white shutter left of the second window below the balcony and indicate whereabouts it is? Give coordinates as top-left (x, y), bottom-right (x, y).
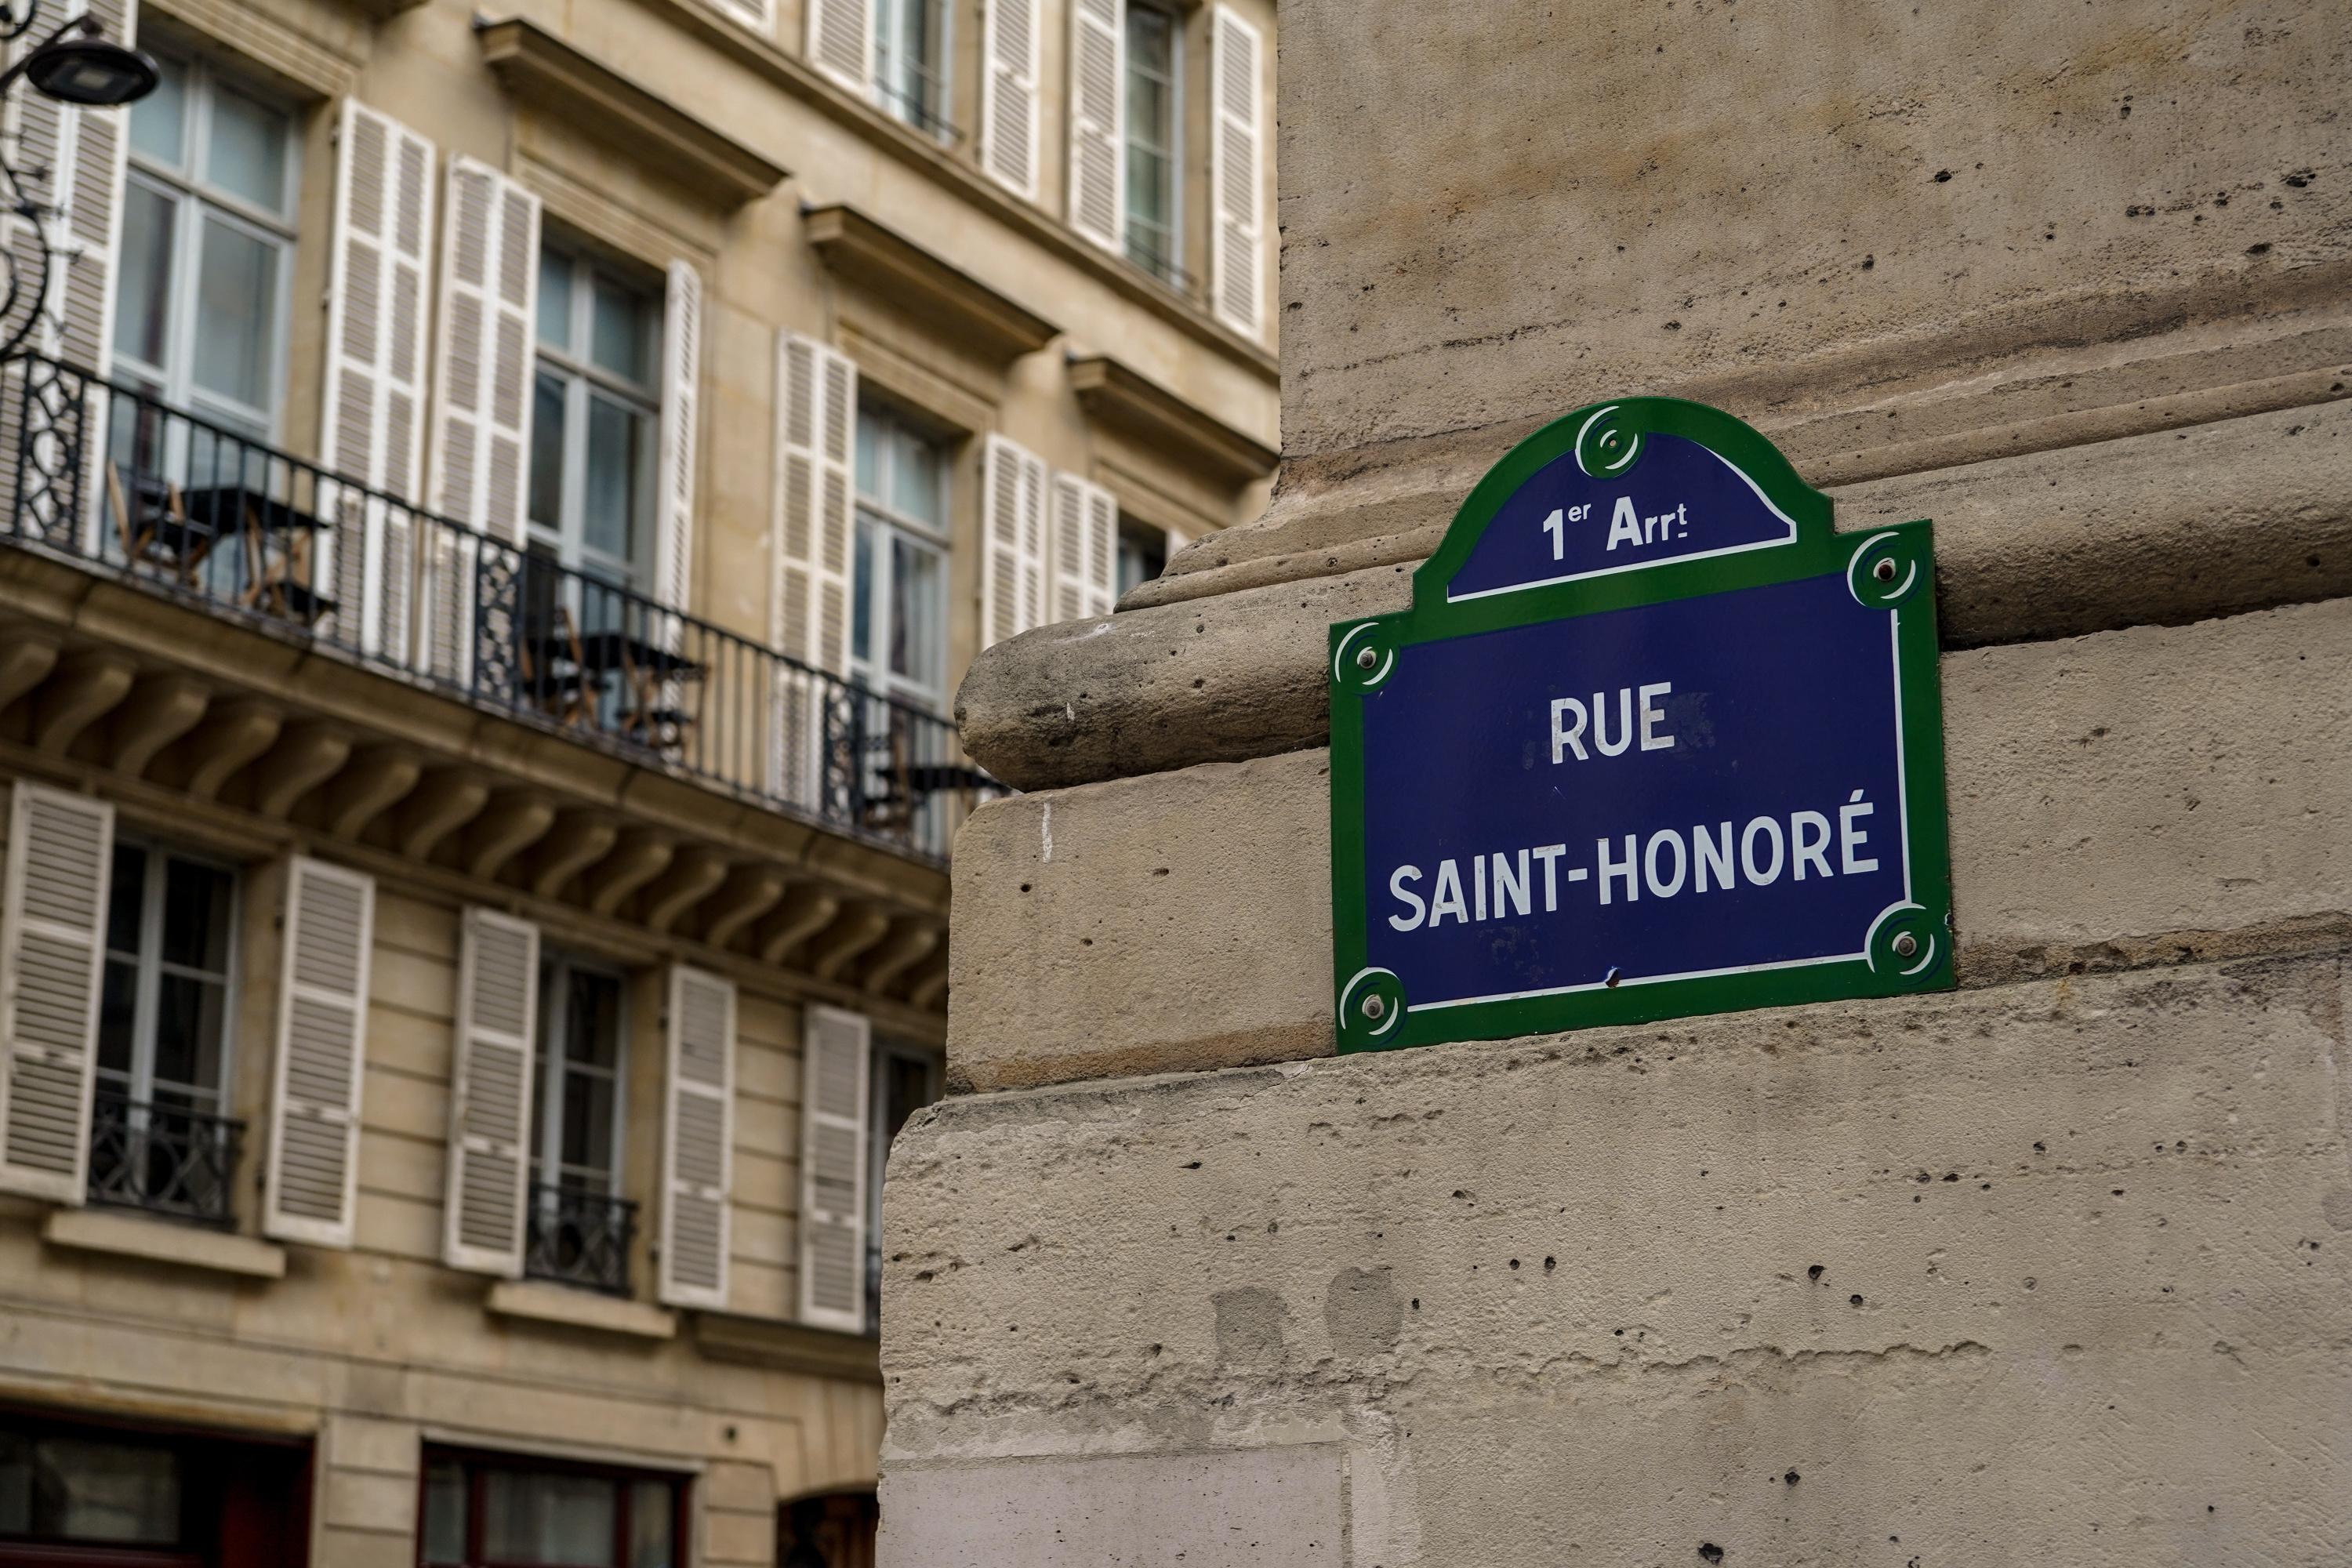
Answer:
top-left (442, 909), bottom-right (539, 1279)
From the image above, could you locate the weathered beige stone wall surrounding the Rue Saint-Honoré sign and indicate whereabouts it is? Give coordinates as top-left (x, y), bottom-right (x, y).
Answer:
top-left (882, 0), bottom-right (2352, 1568)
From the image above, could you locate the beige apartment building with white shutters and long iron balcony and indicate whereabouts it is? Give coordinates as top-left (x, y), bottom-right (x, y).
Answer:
top-left (0, 0), bottom-right (1277, 1568)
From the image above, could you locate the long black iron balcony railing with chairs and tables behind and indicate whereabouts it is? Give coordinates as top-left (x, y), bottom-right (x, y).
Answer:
top-left (0, 355), bottom-right (1000, 860)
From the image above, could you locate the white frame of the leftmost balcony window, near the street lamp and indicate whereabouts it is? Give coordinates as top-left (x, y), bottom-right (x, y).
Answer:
top-left (106, 40), bottom-right (301, 446)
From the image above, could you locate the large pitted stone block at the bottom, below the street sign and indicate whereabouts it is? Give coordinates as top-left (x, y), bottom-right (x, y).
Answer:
top-left (884, 954), bottom-right (2352, 1568)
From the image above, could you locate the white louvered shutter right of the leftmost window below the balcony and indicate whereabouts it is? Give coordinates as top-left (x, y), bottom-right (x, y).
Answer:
top-left (261, 855), bottom-right (376, 1246)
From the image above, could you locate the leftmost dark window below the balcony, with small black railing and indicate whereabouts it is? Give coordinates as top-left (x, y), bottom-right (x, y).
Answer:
top-left (89, 839), bottom-right (240, 1222)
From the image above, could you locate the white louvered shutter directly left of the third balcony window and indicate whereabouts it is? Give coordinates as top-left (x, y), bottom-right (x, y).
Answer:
top-left (767, 332), bottom-right (858, 804)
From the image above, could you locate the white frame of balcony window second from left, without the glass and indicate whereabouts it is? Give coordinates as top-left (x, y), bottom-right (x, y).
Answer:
top-left (536, 248), bottom-right (668, 595)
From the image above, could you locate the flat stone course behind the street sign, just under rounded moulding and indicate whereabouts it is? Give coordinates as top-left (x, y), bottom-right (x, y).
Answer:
top-left (948, 600), bottom-right (2352, 1088)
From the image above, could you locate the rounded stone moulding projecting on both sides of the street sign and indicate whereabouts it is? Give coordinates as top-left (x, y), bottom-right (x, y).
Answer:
top-left (957, 404), bottom-right (2352, 789)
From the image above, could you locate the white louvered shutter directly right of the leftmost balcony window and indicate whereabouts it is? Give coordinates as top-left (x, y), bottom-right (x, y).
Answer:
top-left (320, 99), bottom-right (433, 661)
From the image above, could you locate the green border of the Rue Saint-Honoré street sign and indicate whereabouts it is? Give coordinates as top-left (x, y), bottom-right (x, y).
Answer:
top-left (1327, 397), bottom-right (1957, 1051)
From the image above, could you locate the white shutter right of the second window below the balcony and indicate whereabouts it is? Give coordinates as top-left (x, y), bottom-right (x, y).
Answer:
top-left (659, 964), bottom-right (734, 1307)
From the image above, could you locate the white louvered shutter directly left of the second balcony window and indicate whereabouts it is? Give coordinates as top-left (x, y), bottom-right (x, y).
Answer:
top-left (423, 158), bottom-right (539, 682)
